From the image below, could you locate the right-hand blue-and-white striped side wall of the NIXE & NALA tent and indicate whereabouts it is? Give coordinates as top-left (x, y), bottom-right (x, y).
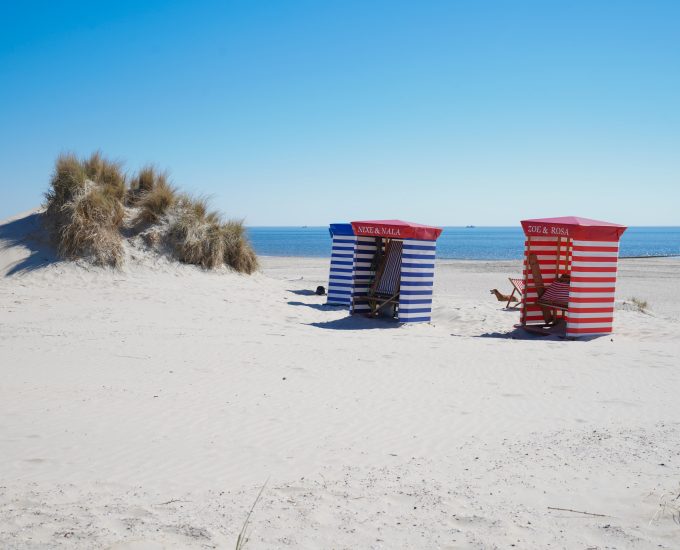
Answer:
top-left (399, 239), bottom-right (437, 323)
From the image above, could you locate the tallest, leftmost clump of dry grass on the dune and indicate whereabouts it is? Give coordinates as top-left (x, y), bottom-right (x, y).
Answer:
top-left (45, 153), bottom-right (125, 266)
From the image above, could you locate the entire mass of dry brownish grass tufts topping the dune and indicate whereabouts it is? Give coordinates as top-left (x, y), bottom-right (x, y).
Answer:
top-left (45, 152), bottom-right (258, 274)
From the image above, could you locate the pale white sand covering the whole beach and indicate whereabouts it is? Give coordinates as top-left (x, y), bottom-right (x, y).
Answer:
top-left (0, 210), bottom-right (680, 549)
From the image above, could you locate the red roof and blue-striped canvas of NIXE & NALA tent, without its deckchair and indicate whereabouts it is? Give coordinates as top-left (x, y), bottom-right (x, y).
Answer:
top-left (350, 220), bottom-right (442, 323)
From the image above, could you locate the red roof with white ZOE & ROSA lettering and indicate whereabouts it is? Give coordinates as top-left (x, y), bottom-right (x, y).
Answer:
top-left (522, 216), bottom-right (627, 241)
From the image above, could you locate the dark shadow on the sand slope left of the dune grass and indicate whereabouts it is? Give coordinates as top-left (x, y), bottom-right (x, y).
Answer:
top-left (0, 212), bottom-right (60, 277)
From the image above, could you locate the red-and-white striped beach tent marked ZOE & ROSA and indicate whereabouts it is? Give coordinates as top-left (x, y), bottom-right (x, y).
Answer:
top-left (520, 216), bottom-right (627, 338)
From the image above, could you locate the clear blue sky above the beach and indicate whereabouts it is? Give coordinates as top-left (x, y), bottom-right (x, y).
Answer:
top-left (0, 0), bottom-right (680, 225)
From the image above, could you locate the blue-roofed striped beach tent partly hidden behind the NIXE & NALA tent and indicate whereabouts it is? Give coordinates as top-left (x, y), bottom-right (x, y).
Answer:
top-left (326, 223), bottom-right (357, 307)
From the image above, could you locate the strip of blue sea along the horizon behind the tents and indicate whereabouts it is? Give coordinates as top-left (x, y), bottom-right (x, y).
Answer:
top-left (248, 227), bottom-right (680, 260)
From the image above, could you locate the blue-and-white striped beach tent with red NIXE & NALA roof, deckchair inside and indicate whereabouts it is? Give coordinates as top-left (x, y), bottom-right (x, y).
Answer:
top-left (350, 220), bottom-right (442, 323)
